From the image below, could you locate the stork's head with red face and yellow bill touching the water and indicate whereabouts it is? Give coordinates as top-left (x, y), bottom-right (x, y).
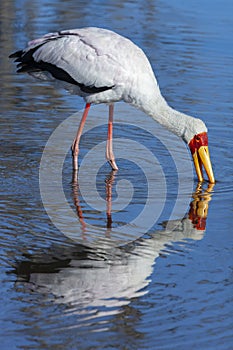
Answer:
top-left (186, 118), bottom-right (215, 183)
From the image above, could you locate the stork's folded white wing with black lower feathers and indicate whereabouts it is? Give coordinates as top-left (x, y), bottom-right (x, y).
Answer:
top-left (16, 28), bottom-right (133, 92)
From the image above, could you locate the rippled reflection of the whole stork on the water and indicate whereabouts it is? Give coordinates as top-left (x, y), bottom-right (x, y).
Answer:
top-left (14, 182), bottom-right (213, 320)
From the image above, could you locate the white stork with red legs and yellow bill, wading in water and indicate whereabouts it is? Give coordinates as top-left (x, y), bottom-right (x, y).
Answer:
top-left (10, 28), bottom-right (214, 182)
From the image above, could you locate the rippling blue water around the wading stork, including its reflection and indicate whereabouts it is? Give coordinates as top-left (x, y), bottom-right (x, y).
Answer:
top-left (0, 0), bottom-right (233, 350)
